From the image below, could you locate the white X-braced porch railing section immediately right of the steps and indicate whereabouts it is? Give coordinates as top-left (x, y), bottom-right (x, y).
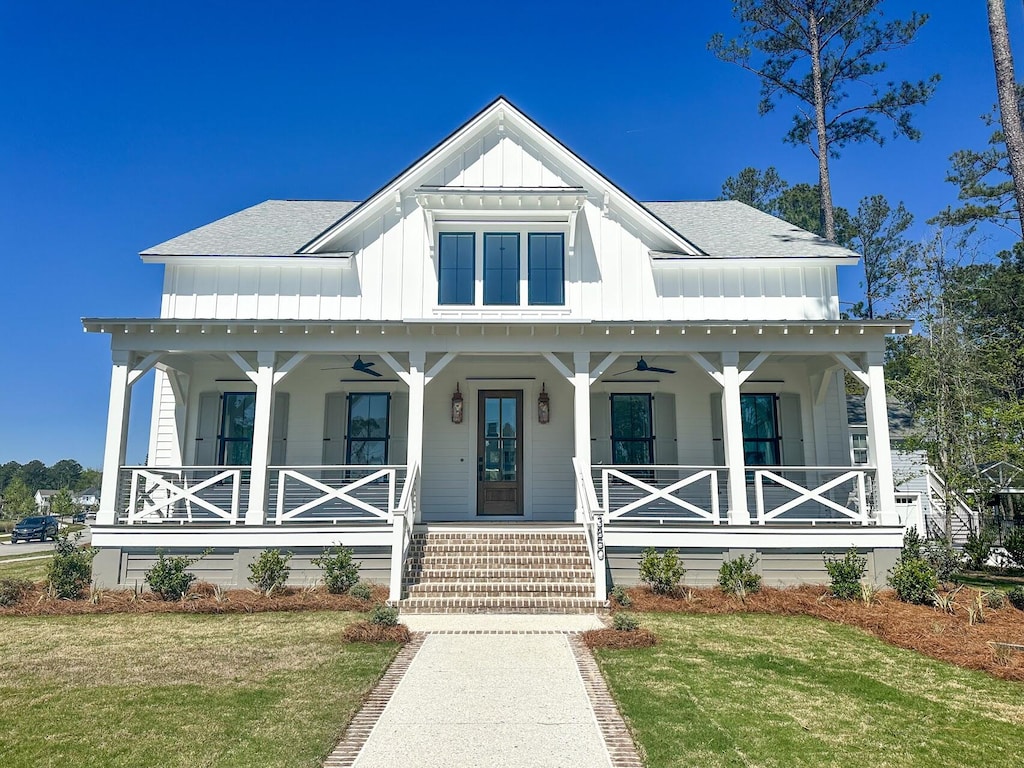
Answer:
top-left (592, 464), bottom-right (728, 525)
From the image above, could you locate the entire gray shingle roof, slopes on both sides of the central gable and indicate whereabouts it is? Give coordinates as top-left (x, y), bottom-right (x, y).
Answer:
top-left (142, 200), bottom-right (857, 258)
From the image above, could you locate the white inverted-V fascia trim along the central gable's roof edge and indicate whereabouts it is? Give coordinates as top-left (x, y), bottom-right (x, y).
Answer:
top-left (300, 98), bottom-right (703, 256)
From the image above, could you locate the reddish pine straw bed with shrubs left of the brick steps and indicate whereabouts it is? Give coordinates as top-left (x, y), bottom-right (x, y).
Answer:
top-left (0, 582), bottom-right (388, 616)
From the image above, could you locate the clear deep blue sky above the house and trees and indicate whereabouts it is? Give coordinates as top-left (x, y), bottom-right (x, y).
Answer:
top-left (0, 0), bottom-right (1024, 467)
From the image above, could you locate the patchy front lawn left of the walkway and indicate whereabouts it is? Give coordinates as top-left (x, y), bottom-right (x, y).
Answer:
top-left (0, 611), bottom-right (398, 768)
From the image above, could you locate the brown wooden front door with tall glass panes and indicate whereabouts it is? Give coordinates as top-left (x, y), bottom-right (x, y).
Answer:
top-left (476, 389), bottom-right (522, 515)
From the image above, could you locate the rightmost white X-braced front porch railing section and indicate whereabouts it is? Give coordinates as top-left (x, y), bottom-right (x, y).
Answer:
top-left (746, 466), bottom-right (878, 525)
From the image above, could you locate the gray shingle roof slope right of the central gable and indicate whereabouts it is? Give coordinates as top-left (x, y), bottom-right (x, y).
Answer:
top-left (642, 200), bottom-right (858, 258)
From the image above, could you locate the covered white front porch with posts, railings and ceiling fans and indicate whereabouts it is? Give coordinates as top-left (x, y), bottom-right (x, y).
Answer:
top-left (86, 319), bottom-right (905, 596)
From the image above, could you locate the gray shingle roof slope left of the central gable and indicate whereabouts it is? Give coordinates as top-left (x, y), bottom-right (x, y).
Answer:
top-left (142, 200), bottom-right (358, 256)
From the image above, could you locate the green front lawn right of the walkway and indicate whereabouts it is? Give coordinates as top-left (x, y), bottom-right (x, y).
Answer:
top-left (594, 613), bottom-right (1024, 768)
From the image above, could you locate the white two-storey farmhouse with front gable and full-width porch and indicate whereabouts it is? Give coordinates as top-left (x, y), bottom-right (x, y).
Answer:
top-left (83, 98), bottom-right (909, 609)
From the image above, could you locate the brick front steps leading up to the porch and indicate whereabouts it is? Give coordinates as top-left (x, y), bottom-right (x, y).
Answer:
top-left (399, 530), bottom-right (604, 613)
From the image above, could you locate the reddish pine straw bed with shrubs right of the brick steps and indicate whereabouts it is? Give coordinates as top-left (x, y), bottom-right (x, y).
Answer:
top-left (614, 586), bottom-right (1024, 681)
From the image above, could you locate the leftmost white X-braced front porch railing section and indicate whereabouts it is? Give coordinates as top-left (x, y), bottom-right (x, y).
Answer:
top-left (117, 467), bottom-right (248, 525)
